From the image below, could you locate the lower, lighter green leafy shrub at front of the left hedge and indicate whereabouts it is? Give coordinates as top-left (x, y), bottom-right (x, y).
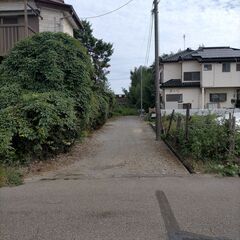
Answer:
top-left (0, 92), bottom-right (78, 164)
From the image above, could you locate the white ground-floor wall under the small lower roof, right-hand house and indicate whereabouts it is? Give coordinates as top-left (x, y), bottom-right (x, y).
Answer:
top-left (164, 88), bottom-right (201, 109)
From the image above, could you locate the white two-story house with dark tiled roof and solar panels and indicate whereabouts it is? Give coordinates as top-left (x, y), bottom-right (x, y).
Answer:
top-left (160, 47), bottom-right (240, 109)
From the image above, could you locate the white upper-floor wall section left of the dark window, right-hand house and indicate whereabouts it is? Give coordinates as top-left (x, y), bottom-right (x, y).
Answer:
top-left (163, 63), bottom-right (181, 82)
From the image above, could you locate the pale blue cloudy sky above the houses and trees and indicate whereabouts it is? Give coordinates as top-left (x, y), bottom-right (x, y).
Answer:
top-left (65, 0), bottom-right (240, 93)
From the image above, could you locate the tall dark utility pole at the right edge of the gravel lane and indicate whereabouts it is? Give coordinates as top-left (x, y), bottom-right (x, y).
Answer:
top-left (153, 0), bottom-right (161, 141)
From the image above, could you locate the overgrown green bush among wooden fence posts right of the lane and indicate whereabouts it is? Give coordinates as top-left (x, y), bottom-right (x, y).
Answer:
top-left (167, 115), bottom-right (240, 162)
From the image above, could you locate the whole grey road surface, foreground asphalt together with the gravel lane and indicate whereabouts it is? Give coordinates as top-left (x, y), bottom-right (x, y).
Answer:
top-left (0, 117), bottom-right (240, 240)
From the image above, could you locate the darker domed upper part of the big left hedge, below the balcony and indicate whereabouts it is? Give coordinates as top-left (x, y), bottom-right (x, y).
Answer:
top-left (0, 32), bottom-right (93, 120)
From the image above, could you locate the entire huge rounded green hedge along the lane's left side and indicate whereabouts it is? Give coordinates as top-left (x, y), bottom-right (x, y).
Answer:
top-left (0, 33), bottom-right (114, 164)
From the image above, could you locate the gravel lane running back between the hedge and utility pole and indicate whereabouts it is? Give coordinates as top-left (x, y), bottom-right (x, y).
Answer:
top-left (32, 117), bottom-right (188, 179)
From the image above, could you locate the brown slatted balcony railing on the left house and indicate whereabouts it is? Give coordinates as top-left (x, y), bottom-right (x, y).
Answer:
top-left (0, 24), bottom-right (35, 56)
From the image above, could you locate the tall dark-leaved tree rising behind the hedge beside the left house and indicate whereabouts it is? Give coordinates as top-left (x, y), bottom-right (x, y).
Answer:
top-left (74, 20), bottom-right (113, 87)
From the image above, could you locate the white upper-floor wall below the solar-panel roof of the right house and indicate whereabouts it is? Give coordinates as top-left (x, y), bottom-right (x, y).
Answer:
top-left (202, 63), bottom-right (240, 87)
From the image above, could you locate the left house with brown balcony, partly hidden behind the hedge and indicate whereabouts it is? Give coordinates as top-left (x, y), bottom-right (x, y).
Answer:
top-left (0, 0), bottom-right (82, 57)
